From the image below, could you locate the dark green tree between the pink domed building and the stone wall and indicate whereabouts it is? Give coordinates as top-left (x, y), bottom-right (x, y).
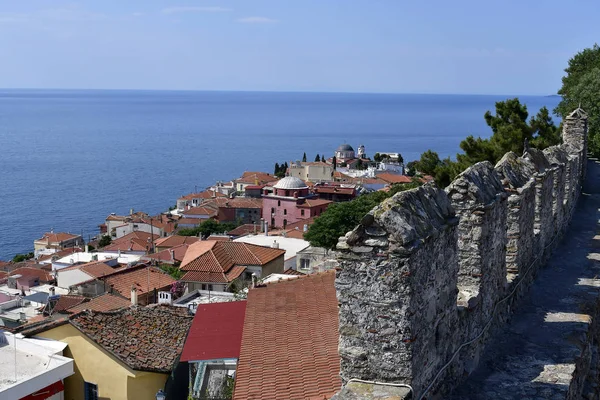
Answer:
top-left (304, 181), bottom-right (421, 249)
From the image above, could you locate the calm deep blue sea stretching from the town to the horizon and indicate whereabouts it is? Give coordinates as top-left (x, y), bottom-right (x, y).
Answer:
top-left (0, 90), bottom-right (558, 260)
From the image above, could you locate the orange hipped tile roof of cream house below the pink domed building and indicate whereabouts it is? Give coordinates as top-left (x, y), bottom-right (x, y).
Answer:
top-left (180, 240), bottom-right (285, 283)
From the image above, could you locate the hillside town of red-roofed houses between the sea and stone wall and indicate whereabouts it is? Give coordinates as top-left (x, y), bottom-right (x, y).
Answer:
top-left (0, 144), bottom-right (412, 399)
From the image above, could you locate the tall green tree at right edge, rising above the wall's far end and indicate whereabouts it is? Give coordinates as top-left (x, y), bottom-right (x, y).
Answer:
top-left (554, 44), bottom-right (600, 157)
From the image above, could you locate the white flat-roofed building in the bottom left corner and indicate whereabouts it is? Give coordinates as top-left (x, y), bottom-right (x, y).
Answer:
top-left (0, 331), bottom-right (73, 400)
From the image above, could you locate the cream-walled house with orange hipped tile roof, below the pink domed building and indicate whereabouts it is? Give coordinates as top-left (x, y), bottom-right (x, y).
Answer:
top-left (180, 240), bottom-right (285, 292)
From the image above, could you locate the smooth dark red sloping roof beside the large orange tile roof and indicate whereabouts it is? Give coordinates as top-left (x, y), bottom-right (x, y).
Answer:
top-left (181, 301), bottom-right (246, 362)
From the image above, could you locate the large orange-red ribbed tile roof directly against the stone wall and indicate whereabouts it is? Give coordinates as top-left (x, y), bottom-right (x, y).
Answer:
top-left (233, 271), bottom-right (341, 400)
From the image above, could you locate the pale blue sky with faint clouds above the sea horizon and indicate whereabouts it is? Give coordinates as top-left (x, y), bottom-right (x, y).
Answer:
top-left (0, 0), bottom-right (600, 95)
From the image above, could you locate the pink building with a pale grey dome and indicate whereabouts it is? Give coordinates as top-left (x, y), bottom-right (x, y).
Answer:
top-left (263, 176), bottom-right (332, 228)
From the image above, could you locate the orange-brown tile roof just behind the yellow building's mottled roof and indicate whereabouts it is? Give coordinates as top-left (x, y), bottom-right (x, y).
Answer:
top-left (101, 264), bottom-right (175, 299)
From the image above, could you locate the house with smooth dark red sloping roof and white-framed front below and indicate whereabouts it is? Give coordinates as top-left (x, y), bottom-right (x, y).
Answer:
top-left (181, 301), bottom-right (246, 399)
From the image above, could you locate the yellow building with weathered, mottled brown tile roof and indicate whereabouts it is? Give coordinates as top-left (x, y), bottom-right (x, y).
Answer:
top-left (24, 306), bottom-right (192, 400)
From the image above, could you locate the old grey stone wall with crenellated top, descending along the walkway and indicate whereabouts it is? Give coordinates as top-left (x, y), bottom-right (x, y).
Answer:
top-left (336, 109), bottom-right (587, 399)
